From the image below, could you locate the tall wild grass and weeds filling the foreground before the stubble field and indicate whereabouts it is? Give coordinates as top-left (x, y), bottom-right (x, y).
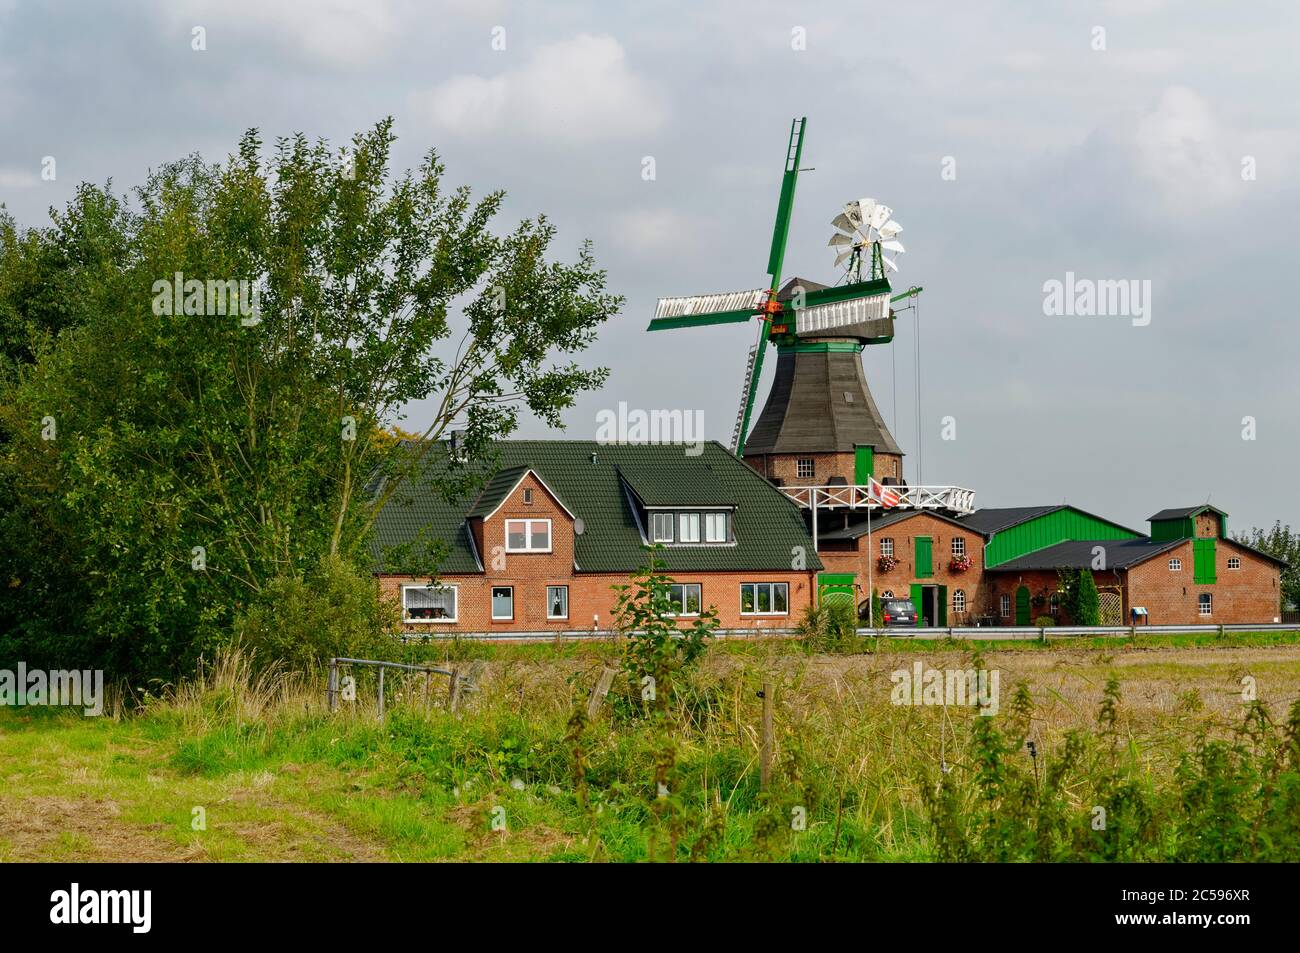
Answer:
top-left (40, 644), bottom-right (1300, 861)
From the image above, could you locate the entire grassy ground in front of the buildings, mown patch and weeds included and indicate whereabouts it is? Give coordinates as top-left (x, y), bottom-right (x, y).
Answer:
top-left (0, 633), bottom-right (1300, 861)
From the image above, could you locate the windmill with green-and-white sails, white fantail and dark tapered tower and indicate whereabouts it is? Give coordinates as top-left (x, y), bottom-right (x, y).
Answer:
top-left (649, 118), bottom-right (920, 486)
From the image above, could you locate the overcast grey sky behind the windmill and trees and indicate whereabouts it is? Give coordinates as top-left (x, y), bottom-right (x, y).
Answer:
top-left (0, 0), bottom-right (1300, 529)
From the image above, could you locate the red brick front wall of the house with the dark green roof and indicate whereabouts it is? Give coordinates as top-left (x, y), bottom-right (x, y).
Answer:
top-left (380, 475), bottom-right (811, 634)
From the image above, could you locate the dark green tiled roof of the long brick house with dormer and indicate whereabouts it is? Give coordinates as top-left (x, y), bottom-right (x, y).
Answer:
top-left (372, 441), bottom-right (822, 573)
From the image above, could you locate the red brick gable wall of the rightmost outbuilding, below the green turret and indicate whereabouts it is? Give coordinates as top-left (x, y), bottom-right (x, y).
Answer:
top-left (1125, 535), bottom-right (1282, 625)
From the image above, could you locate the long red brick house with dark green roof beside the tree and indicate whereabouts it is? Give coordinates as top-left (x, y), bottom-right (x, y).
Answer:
top-left (373, 441), bottom-right (822, 636)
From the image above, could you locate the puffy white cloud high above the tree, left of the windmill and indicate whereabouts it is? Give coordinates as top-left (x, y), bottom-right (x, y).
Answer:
top-left (411, 34), bottom-right (667, 142)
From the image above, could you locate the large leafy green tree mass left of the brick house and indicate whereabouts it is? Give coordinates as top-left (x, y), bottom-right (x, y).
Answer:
top-left (0, 120), bottom-right (621, 677)
